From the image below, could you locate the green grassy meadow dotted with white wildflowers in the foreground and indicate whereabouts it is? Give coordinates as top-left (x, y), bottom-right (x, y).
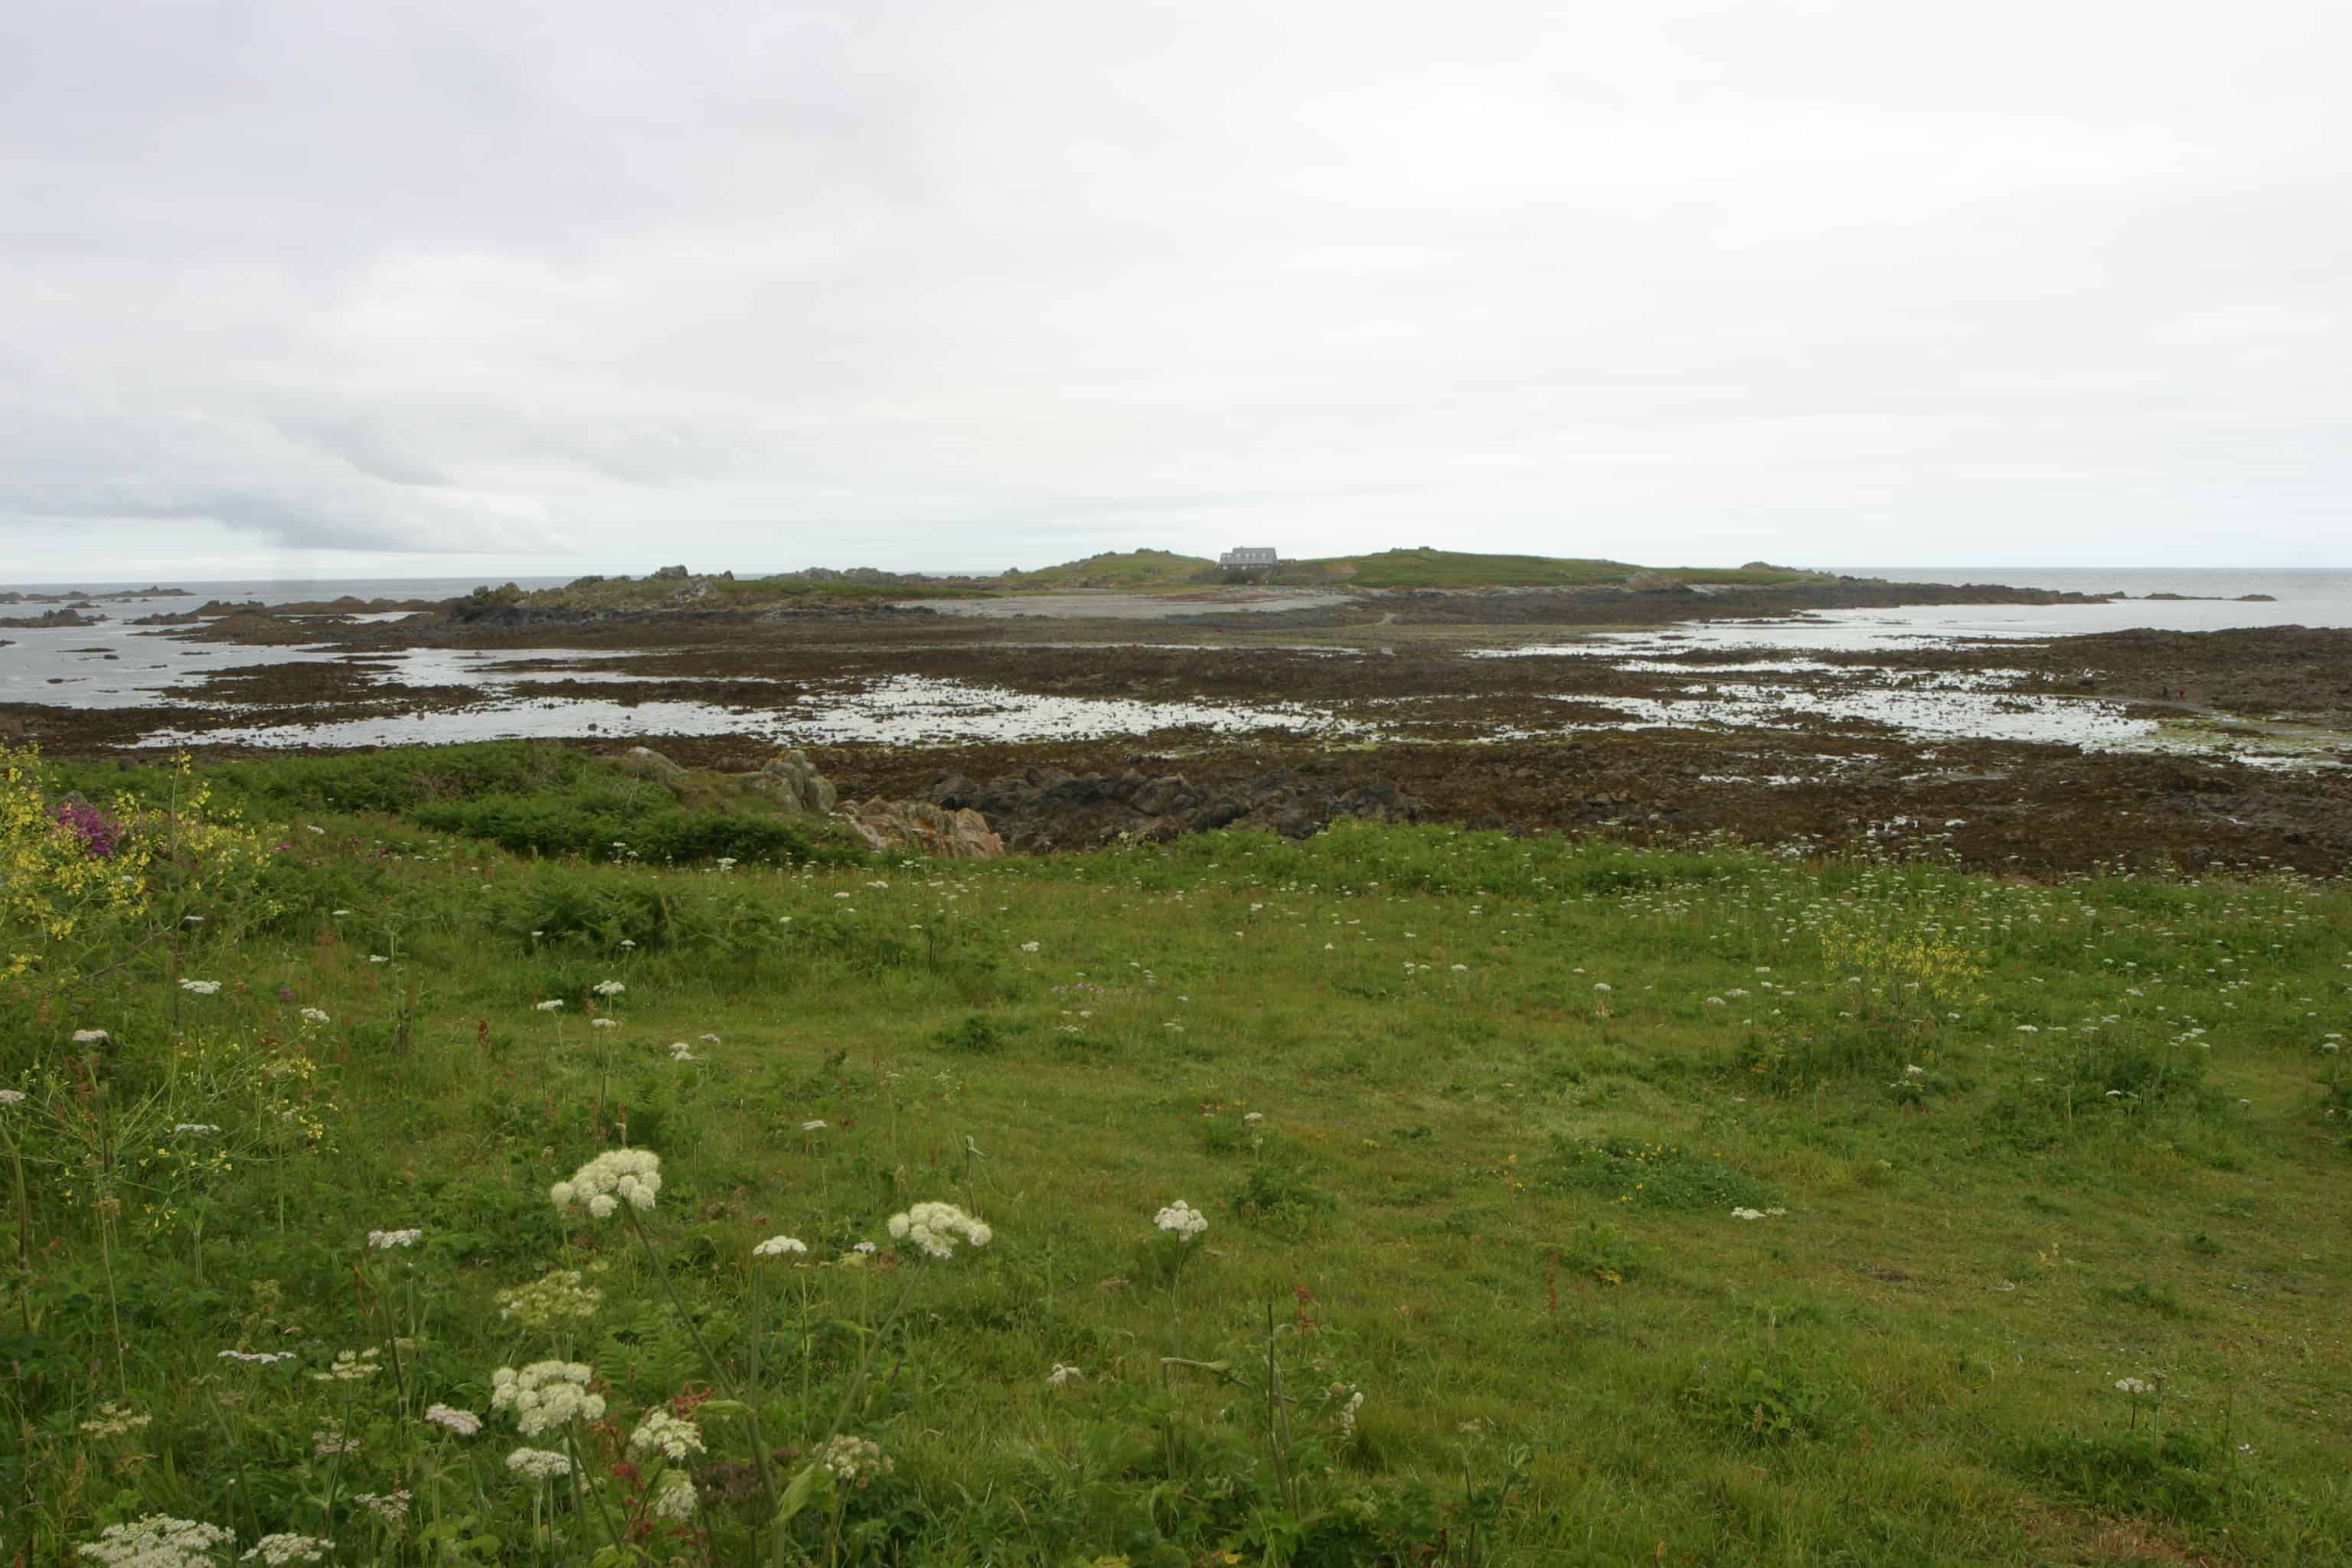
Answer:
top-left (0, 747), bottom-right (2352, 1568)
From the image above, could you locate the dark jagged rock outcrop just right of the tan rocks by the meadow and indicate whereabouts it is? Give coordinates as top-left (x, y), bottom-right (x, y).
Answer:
top-left (924, 769), bottom-right (1420, 851)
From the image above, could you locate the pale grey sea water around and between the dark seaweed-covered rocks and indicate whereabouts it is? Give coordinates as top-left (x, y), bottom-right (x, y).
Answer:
top-left (0, 567), bottom-right (2352, 762)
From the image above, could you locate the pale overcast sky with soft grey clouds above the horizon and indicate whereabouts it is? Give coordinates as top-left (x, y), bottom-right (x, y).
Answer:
top-left (0, 0), bottom-right (2352, 580)
